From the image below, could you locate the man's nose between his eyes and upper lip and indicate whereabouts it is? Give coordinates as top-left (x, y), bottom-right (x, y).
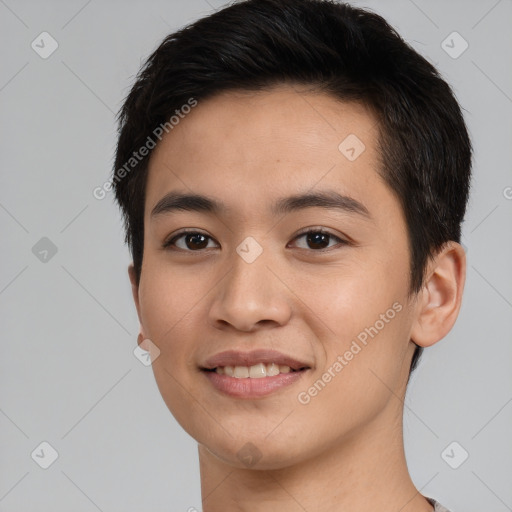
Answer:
top-left (209, 243), bottom-right (292, 332)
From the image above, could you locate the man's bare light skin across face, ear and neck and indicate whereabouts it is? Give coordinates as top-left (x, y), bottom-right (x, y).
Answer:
top-left (129, 85), bottom-right (466, 512)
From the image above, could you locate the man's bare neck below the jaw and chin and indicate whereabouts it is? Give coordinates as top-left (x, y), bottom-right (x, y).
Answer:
top-left (199, 402), bottom-right (433, 512)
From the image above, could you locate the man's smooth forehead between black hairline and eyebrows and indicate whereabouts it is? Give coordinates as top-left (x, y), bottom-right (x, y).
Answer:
top-left (146, 85), bottom-right (382, 220)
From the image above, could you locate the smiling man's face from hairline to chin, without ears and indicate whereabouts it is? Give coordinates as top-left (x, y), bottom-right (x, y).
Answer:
top-left (131, 86), bottom-right (422, 469)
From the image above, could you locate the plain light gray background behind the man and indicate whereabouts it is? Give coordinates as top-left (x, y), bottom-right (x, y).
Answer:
top-left (0, 0), bottom-right (512, 512)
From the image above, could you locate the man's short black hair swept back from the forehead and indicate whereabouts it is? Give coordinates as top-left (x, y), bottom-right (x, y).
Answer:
top-left (111, 0), bottom-right (472, 375)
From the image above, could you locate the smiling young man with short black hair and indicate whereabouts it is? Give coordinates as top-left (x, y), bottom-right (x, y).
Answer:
top-left (112, 0), bottom-right (471, 512)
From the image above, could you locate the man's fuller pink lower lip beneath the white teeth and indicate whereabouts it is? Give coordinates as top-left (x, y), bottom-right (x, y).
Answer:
top-left (203, 370), bottom-right (307, 398)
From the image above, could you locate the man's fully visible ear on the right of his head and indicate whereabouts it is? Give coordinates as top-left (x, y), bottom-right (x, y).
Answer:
top-left (411, 241), bottom-right (466, 347)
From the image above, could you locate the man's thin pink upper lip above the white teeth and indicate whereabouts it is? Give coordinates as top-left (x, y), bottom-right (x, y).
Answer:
top-left (202, 349), bottom-right (310, 370)
